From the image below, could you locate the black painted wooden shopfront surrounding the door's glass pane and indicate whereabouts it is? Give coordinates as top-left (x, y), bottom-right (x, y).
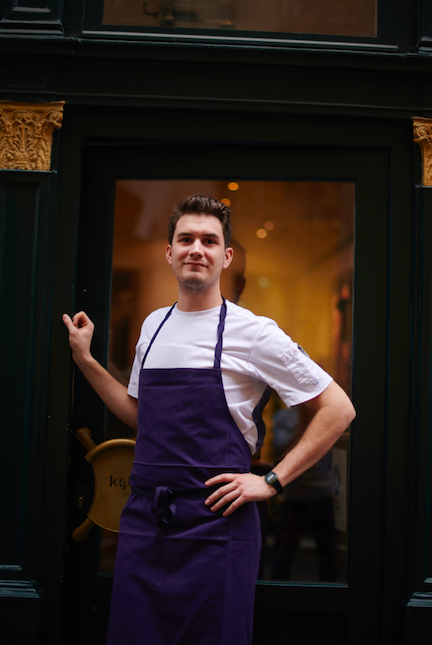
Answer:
top-left (0, 0), bottom-right (432, 645)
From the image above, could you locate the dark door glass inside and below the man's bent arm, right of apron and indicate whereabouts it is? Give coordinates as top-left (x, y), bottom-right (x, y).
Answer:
top-left (257, 394), bottom-right (349, 582)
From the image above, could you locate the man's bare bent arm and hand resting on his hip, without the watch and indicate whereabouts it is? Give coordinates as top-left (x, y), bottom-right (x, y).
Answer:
top-left (205, 381), bottom-right (355, 516)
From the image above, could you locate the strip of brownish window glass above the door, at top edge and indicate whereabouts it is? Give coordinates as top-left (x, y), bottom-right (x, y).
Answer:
top-left (103, 0), bottom-right (377, 37)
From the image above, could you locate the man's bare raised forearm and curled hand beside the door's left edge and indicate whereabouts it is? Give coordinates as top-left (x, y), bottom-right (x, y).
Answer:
top-left (63, 311), bottom-right (138, 429)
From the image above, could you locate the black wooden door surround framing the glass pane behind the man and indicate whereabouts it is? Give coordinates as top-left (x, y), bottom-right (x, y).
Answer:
top-left (67, 144), bottom-right (388, 645)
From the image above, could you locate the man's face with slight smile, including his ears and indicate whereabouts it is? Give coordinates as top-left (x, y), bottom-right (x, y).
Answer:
top-left (166, 214), bottom-right (233, 293)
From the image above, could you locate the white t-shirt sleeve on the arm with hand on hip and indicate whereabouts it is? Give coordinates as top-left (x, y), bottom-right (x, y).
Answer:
top-left (246, 319), bottom-right (333, 407)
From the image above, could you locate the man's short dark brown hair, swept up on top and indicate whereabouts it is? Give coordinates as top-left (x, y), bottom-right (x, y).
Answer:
top-left (168, 195), bottom-right (231, 248)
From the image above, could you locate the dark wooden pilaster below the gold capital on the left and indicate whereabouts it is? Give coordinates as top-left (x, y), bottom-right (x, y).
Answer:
top-left (0, 171), bottom-right (55, 643)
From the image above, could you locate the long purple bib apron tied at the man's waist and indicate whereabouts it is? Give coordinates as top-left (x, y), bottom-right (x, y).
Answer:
top-left (108, 301), bottom-right (261, 645)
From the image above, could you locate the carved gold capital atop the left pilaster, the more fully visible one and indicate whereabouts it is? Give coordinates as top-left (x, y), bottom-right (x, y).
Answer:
top-left (0, 101), bottom-right (64, 170)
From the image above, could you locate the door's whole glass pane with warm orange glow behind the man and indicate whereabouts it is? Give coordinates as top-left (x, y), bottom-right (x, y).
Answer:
top-left (100, 180), bottom-right (355, 582)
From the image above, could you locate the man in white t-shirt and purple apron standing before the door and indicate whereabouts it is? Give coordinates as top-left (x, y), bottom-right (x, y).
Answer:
top-left (63, 195), bottom-right (355, 645)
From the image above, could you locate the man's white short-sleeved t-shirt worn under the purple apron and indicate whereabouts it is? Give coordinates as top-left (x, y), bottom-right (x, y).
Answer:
top-left (128, 300), bottom-right (332, 454)
